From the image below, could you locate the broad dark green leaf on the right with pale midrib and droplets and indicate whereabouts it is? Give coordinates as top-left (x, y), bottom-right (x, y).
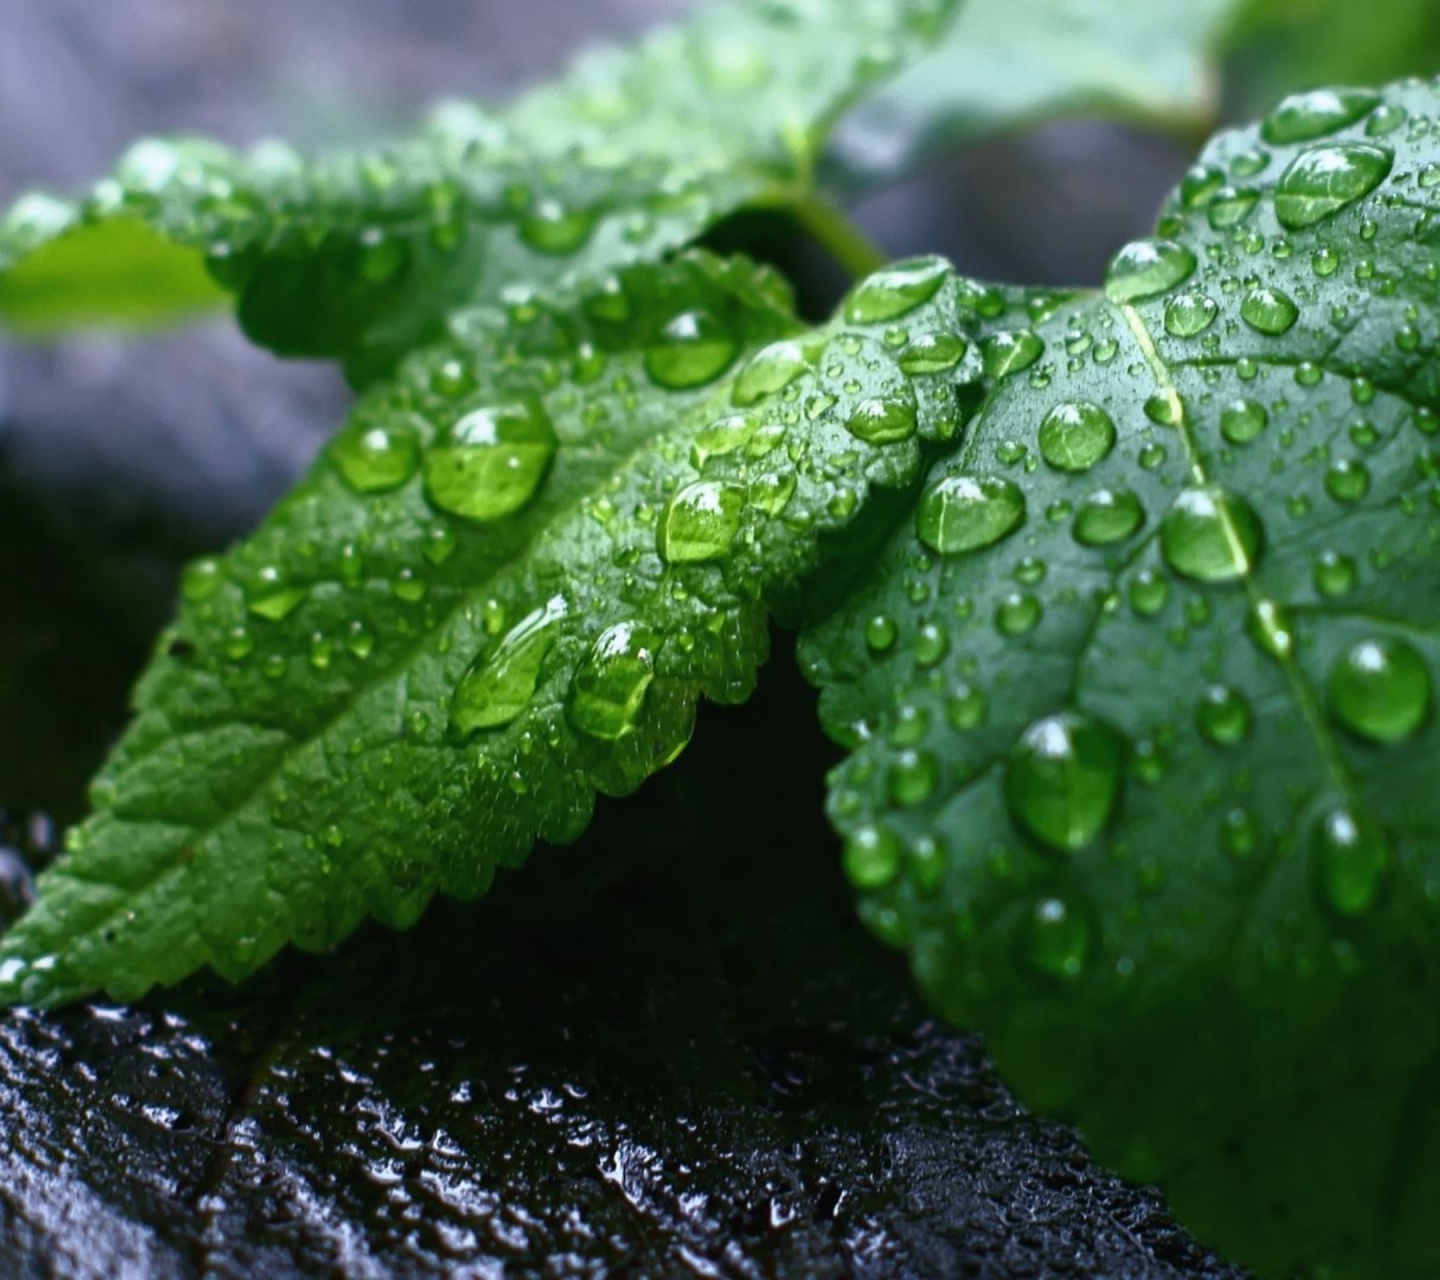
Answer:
top-left (804, 82), bottom-right (1440, 1277)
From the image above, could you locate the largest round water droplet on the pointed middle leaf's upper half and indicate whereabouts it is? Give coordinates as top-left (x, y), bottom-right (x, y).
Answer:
top-left (425, 397), bottom-right (559, 520)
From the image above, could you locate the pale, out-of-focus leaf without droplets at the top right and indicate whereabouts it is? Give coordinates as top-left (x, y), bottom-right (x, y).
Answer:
top-left (835, 0), bottom-right (1241, 186)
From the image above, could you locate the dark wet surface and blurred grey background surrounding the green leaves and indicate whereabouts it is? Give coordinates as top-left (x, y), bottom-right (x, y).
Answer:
top-left (0, 0), bottom-right (1255, 1280)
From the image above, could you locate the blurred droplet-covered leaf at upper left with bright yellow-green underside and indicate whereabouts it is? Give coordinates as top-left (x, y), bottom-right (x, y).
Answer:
top-left (0, 0), bottom-right (953, 382)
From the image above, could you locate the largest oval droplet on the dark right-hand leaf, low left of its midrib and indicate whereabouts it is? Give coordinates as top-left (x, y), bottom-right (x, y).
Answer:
top-left (1005, 711), bottom-right (1125, 849)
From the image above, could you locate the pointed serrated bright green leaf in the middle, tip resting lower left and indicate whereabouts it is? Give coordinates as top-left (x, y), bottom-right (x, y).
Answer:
top-left (0, 247), bottom-right (979, 1004)
